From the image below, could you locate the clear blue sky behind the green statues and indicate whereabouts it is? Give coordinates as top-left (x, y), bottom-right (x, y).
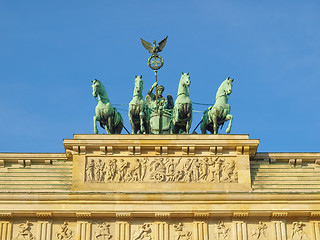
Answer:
top-left (0, 0), bottom-right (320, 152)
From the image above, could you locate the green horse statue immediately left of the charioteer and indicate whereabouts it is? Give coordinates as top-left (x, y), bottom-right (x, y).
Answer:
top-left (128, 75), bottom-right (150, 134)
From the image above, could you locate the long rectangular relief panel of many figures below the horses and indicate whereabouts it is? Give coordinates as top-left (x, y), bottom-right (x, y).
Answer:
top-left (84, 157), bottom-right (238, 183)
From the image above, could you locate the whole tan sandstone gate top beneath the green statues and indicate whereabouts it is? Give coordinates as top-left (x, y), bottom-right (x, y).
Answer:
top-left (0, 135), bottom-right (320, 240)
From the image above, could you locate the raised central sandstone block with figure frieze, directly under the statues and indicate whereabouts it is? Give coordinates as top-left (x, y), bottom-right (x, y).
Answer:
top-left (64, 135), bottom-right (259, 193)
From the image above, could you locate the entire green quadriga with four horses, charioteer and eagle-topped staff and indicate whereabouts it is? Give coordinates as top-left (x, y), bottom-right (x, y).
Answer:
top-left (92, 37), bottom-right (233, 134)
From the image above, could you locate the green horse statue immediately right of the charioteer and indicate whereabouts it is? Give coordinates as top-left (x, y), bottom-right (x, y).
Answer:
top-left (172, 73), bottom-right (192, 134)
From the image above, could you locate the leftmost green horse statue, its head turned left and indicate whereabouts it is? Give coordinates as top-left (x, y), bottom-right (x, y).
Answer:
top-left (92, 79), bottom-right (123, 134)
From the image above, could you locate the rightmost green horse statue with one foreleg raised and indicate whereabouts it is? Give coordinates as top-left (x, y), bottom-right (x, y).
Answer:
top-left (200, 77), bottom-right (234, 134)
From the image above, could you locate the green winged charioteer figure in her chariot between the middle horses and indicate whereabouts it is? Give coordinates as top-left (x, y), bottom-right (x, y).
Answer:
top-left (145, 82), bottom-right (173, 134)
